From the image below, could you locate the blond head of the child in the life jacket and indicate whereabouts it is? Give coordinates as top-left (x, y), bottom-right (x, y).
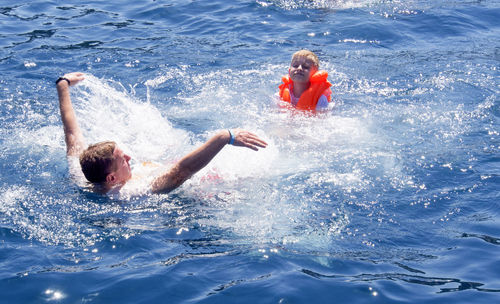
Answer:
top-left (288, 50), bottom-right (319, 83)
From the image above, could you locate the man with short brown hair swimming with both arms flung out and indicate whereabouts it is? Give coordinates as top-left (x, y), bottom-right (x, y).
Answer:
top-left (56, 73), bottom-right (267, 193)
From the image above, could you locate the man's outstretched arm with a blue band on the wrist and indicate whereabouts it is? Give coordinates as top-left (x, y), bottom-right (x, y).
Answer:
top-left (152, 129), bottom-right (267, 193)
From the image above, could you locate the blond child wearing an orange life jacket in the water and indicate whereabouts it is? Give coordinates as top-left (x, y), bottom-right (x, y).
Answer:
top-left (279, 50), bottom-right (332, 110)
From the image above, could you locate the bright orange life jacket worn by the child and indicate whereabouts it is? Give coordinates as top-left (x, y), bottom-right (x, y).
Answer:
top-left (279, 71), bottom-right (332, 110)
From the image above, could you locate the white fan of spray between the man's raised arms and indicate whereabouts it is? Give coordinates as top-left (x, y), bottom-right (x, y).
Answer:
top-left (74, 75), bottom-right (189, 160)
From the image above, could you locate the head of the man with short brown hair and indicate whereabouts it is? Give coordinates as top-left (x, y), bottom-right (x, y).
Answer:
top-left (80, 141), bottom-right (132, 185)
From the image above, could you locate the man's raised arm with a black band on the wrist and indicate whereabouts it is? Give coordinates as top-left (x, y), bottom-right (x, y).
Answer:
top-left (56, 72), bottom-right (85, 156)
